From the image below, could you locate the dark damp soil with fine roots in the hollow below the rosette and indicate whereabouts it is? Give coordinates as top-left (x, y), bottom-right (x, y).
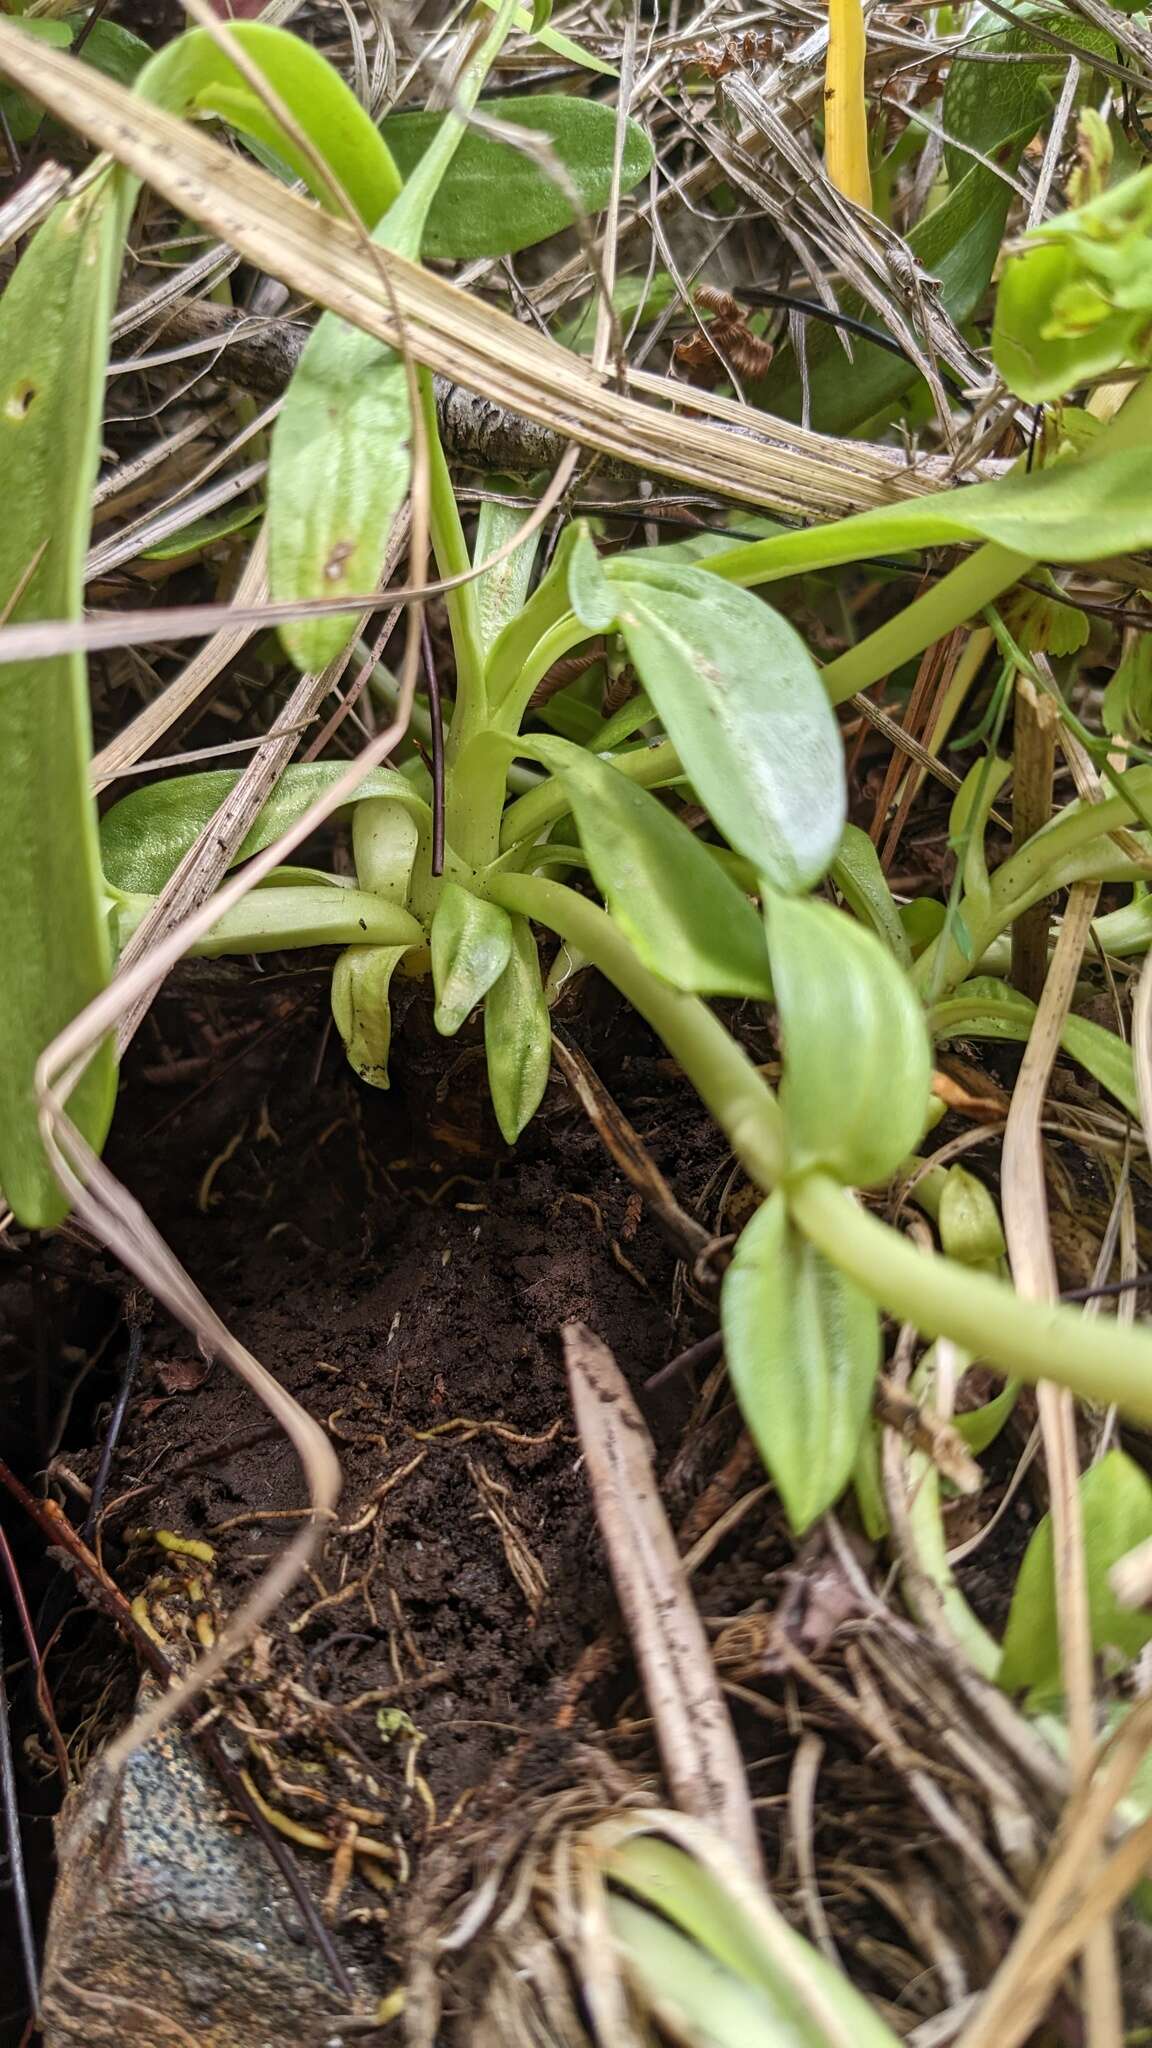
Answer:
top-left (0, 963), bottom-right (732, 2023)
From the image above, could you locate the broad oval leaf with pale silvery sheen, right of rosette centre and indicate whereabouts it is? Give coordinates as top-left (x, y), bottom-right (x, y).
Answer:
top-left (605, 561), bottom-right (845, 889)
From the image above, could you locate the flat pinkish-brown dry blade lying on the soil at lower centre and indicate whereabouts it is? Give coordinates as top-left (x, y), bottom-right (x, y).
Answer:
top-left (564, 1323), bottom-right (760, 1876)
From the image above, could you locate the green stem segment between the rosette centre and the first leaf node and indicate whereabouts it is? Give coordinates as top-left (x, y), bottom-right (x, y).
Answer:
top-left (479, 874), bottom-right (785, 1188)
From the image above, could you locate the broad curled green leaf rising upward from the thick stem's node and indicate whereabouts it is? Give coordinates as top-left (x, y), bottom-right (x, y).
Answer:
top-left (765, 895), bottom-right (933, 1188)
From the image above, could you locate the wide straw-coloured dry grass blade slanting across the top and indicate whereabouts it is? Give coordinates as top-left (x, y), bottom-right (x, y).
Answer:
top-left (0, 20), bottom-right (959, 520)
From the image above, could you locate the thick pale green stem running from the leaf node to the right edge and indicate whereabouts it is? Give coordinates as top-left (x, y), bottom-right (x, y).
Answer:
top-left (789, 1174), bottom-right (1152, 1421)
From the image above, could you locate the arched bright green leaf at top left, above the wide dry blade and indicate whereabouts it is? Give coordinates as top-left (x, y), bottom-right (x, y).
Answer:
top-left (137, 20), bottom-right (400, 227)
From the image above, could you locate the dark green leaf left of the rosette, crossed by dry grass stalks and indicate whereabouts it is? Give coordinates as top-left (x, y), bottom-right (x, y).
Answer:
top-left (100, 762), bottom-right (430, 895)
